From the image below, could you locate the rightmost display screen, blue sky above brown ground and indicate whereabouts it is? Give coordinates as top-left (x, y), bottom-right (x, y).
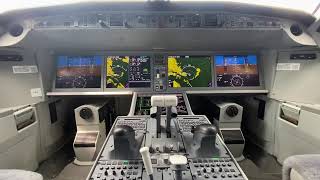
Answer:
top-left (215, 55), bottom-right (260, 87)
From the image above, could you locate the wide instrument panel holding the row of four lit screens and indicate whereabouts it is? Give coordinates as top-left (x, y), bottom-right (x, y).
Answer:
top-left (53, 53), bottom-right (263, 92)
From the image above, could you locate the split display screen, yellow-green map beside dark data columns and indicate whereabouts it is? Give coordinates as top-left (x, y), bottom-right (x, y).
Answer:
top-left (106, 56), bottom-right (151, 88)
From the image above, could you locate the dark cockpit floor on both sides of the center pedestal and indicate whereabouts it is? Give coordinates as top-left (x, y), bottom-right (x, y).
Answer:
top-left (37, 141), bottom-right (281, 180)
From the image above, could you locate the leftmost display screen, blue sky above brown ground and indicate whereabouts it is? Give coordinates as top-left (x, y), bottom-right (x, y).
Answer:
top-left (55, 56), bottom-right (103, 88)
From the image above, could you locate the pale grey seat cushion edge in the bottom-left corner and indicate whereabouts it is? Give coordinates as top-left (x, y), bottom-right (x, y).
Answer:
top-left (0, 169), bottom-right (43, 180)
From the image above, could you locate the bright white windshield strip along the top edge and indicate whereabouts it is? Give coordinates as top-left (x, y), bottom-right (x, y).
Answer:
top-left (0, 0), bottom-right (320, 16)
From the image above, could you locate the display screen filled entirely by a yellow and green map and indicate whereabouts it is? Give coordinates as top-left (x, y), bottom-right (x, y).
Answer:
top-left (168, 56), bottom-right (212, 88)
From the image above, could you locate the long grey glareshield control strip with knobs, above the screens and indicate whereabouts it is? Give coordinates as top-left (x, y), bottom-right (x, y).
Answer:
top-left (34, 11), bottom-right (281, 29)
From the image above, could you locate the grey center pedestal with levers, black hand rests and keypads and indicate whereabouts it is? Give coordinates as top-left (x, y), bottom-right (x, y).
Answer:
top-left (87, 95), bottom-right (247, 180)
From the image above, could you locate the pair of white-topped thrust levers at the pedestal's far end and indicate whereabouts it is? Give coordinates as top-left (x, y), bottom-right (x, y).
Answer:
top-left (150, 95), bottom-right (178, 136)
